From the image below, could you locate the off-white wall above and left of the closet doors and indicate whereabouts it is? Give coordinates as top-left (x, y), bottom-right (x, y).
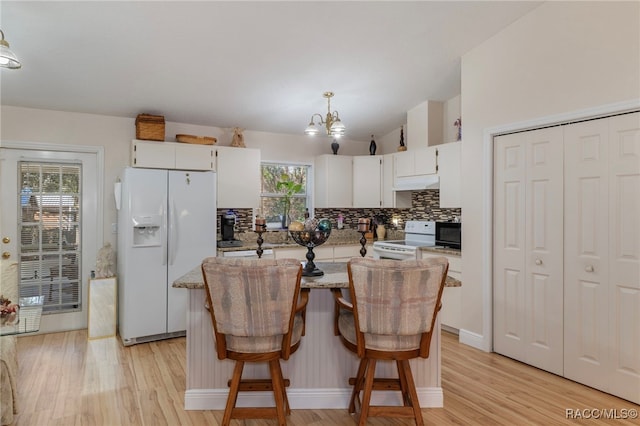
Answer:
top-left (460, 2), bottom-right (640, 349)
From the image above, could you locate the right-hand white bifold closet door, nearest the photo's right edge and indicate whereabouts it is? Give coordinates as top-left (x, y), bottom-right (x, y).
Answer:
top-left (564, 113), bottom-right (640, 403)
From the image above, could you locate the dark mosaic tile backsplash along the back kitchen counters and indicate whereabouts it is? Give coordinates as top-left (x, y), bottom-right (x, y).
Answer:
top-left (216, 189), bottom-right (462, 233)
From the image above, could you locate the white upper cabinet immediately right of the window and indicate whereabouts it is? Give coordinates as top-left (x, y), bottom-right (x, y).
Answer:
top-left (314, 154), bottom-right (353, 208)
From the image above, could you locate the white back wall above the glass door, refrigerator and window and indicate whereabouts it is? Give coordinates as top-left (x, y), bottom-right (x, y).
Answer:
top-left (0, 106), bottom-right (369, 253)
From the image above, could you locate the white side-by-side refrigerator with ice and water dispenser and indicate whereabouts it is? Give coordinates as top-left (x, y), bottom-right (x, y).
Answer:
top-left (115, 167), bottom-right (216, 345)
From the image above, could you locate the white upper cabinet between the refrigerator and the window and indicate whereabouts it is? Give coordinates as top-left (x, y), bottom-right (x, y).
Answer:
top-left (216, 146), bottom-right (260, 208)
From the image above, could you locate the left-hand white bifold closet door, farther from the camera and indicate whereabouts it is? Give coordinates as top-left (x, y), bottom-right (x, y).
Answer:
top-left (493, 127), bottom-right (564, 374)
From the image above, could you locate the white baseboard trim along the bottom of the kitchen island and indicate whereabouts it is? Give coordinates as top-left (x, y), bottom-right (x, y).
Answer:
top-left (184, 387), bottom-right (444, 410)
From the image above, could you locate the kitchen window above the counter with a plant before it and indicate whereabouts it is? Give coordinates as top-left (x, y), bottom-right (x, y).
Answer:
top-left (260, 162), bottom-right (312, 229)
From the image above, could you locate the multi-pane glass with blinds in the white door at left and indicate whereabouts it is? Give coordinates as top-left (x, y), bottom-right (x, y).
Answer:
top-left (18, 162), bottom-right (82, 313)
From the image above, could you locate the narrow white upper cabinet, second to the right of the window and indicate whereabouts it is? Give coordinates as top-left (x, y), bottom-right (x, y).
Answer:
top-left (353, 155), bottom-right (383, 208)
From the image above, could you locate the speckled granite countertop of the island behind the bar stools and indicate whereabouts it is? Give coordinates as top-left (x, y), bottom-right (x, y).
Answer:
top-left (173, 262), bottom-right (462, 290)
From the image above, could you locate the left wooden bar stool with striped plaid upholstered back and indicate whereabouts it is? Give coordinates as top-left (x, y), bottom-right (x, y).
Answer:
top-left (202, 257), bottom-right (308, 426)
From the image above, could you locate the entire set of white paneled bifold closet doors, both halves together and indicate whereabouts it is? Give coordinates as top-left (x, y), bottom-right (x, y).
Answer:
top-left (493, 113), bottom-right (640, 403)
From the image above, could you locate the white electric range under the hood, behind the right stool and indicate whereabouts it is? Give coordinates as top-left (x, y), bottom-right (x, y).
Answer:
top-left (373, 220), bottom-right (436, 260)
